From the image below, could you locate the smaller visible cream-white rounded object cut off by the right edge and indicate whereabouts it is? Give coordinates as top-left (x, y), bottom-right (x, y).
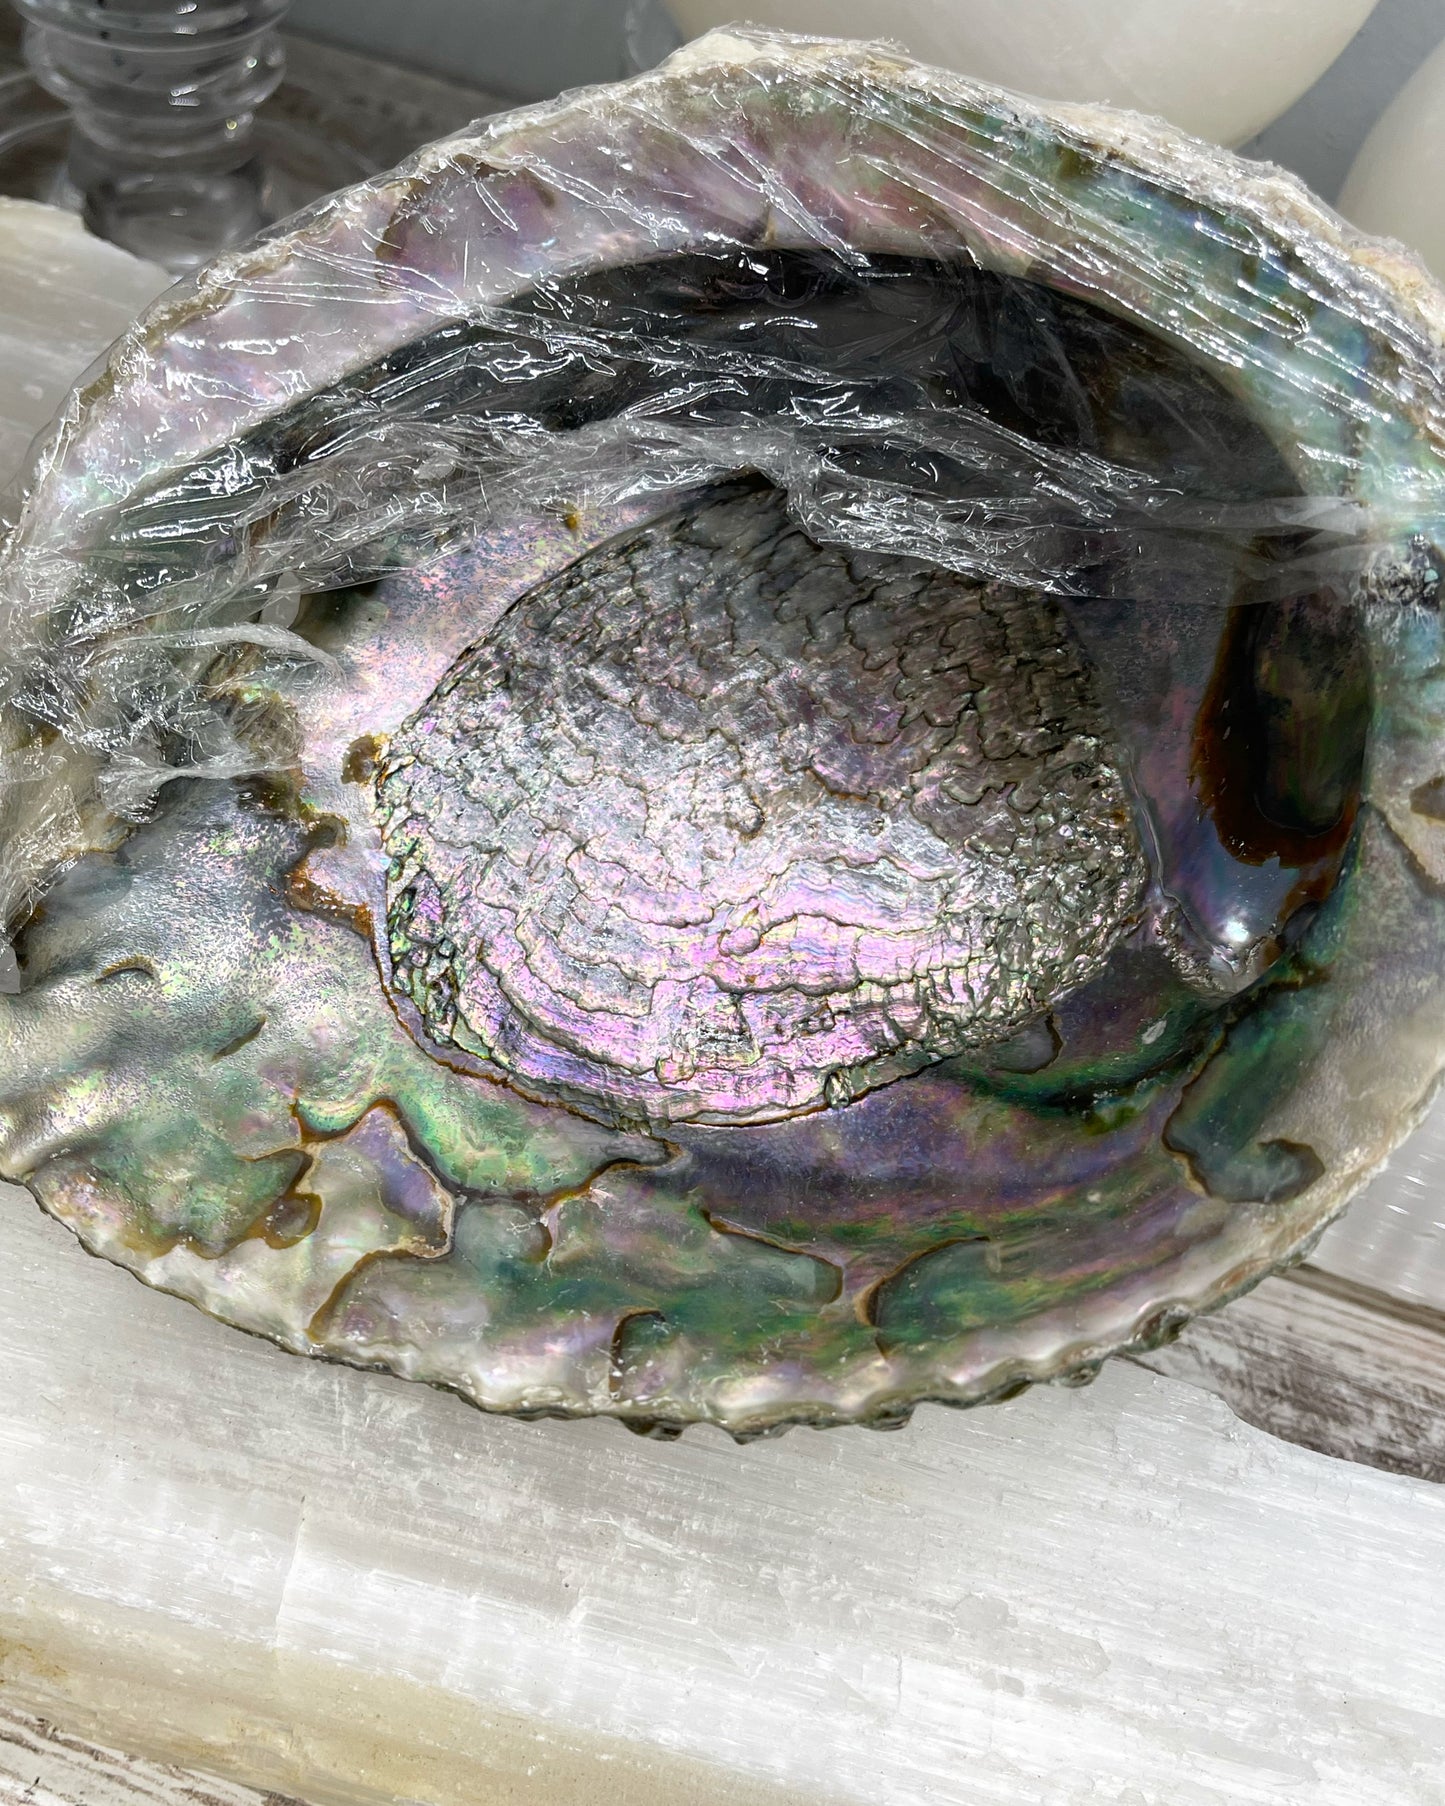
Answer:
top-left (1340, 30), bottom-right (1445, 278)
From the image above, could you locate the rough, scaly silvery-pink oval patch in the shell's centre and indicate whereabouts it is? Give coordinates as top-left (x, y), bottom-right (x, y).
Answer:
top-left (378, 488), bottom-right (1147, 1122)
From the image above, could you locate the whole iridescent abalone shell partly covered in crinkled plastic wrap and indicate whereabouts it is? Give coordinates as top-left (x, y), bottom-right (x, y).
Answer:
top-left (0, 33), bottom-right (1445, 1434)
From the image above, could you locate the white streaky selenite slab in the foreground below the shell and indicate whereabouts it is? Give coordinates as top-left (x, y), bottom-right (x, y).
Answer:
top-left (0, 1190), bottom-right (1445, 1806)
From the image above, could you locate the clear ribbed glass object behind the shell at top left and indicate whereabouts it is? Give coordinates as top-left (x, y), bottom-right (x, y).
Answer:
top-left (16, 0), bottom-right (289, 271)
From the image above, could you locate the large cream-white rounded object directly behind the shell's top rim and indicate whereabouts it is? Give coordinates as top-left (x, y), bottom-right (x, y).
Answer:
top-left (668, 0), bottom-right (1375, 144)
